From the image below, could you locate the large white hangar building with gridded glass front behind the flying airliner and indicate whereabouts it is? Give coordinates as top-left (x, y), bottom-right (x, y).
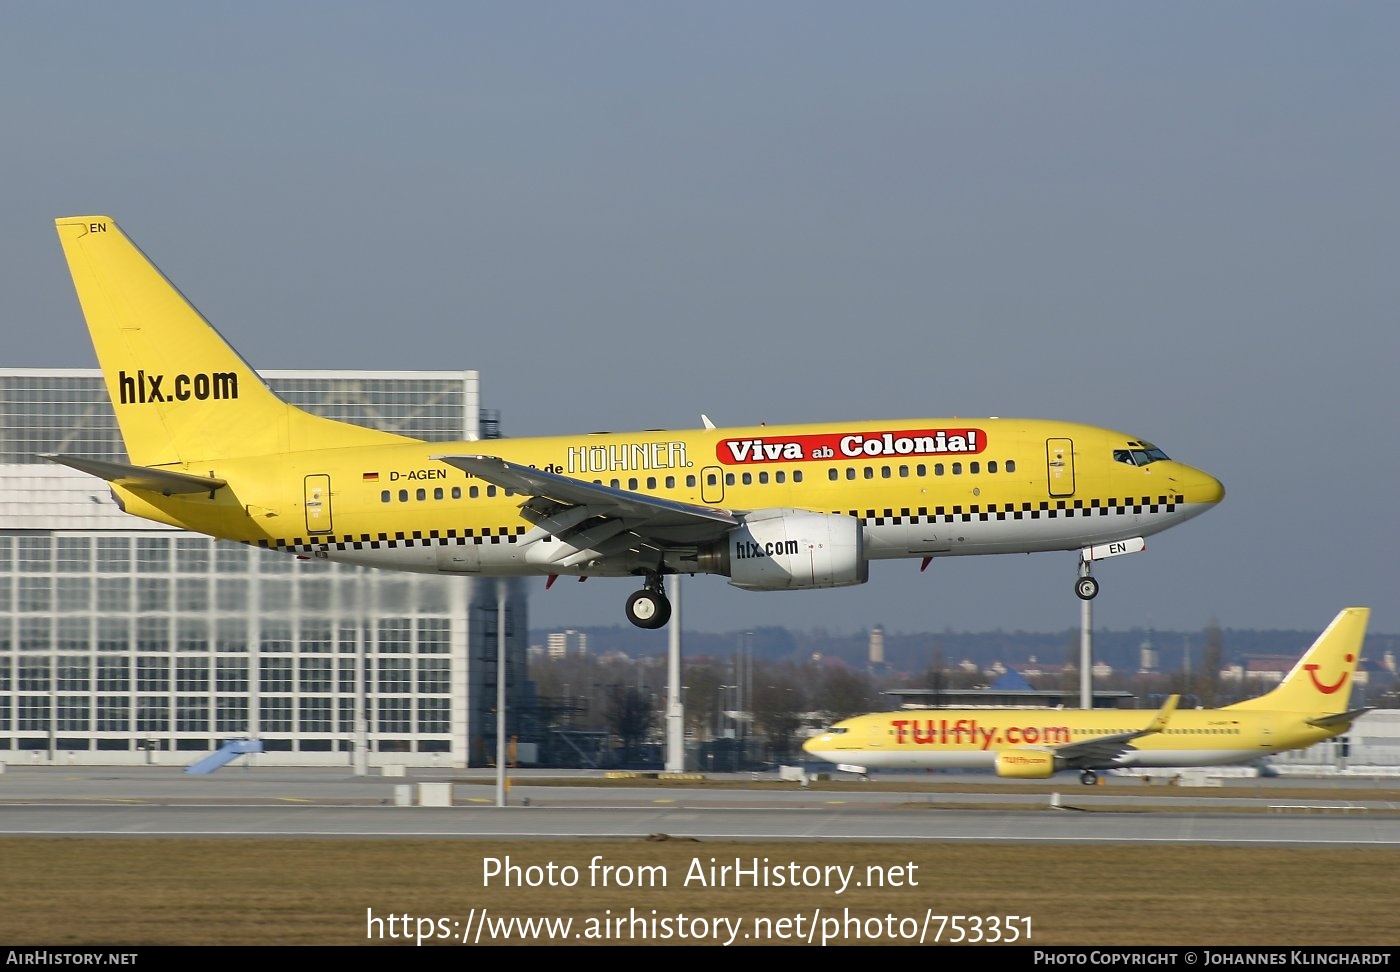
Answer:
top-left (0, 370), bottom-right (529, 766)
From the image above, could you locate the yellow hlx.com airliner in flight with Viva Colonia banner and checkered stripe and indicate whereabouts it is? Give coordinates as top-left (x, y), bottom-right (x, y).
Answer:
top-left (45, 216), bottom-right (1224, 627)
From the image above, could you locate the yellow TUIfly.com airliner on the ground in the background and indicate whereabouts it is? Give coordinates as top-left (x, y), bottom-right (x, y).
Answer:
top-left (802, 608), bottom-right (1371, 783)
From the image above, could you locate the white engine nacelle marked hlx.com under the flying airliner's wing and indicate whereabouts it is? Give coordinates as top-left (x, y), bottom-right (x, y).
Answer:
top-left (700, 510), bottom-right (869, 591)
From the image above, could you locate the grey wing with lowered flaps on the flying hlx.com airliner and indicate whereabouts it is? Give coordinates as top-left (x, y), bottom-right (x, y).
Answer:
top-left (430, 455), bottom-right (739, 564)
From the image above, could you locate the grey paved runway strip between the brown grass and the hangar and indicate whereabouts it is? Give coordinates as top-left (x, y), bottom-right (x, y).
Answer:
top-left (0, 768), bottom-right (1400, 847)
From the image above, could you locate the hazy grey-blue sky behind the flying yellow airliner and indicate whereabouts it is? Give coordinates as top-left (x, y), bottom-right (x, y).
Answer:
top-left (0, 1), bottom-right (1400, 637)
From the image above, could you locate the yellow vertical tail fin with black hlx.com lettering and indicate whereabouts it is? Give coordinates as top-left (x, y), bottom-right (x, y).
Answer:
top-left (55, 216), bottom-right (406, 466)
